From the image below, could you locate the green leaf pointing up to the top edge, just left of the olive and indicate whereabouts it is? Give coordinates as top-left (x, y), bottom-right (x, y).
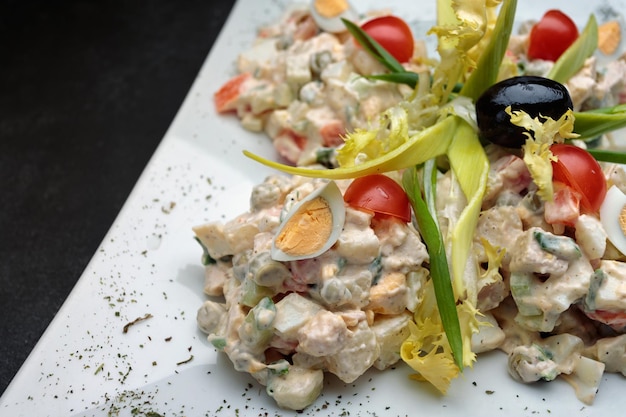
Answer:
top-left (461, 0), bottom-right (517, 100)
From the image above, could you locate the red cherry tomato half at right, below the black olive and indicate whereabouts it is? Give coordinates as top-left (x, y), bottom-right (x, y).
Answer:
top-left (550, 143), bottom-right (606, 212)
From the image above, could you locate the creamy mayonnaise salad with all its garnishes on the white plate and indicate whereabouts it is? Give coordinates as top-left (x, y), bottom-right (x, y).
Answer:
top-left (194, 0), bottom-right (626, 410)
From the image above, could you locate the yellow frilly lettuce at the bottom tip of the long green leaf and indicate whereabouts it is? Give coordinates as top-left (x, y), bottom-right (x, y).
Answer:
top-left (400, 280), bottom-right (481, 394)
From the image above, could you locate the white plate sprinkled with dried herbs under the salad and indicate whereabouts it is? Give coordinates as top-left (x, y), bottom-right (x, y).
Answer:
top-left (0, 0), bottom-right (626, 417)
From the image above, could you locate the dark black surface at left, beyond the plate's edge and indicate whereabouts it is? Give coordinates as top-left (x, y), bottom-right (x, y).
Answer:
top-left (0, 0), bottom-right (234, 393)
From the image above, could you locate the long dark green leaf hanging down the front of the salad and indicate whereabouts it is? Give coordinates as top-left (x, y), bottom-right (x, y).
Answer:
top-left (402, 163), bottom-right (463, 369)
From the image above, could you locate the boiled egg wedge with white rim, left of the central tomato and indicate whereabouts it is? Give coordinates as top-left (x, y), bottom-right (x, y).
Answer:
top-left (271, 181), bottom-right (346, 261)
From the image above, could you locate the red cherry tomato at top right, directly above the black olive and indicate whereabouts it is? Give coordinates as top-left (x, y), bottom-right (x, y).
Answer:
top-left (528, 10), bottom-right (578, 61)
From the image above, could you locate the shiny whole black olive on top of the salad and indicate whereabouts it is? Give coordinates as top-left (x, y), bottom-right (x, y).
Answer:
top-left (476, 75), bottom-right (573, 148)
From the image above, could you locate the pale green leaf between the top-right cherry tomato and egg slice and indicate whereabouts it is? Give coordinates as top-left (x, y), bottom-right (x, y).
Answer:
top-left (546, 15), bottom-right (598, 83)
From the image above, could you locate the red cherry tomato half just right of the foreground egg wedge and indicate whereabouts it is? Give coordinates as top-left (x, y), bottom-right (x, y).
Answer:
top-left (343, 174), bottom-right (411, 223)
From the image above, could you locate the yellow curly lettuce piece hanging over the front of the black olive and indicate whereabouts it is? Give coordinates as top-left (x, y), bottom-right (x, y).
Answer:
top-left (505, 106), bottom-right (578, 201)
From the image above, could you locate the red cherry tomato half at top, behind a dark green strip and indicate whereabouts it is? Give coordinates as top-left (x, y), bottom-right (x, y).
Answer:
top-left (361, 15), bottom-right (414, 63)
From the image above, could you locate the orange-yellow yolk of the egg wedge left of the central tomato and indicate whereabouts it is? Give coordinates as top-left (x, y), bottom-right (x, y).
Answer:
top-left (275, 197), bottom-right (333, 256)
